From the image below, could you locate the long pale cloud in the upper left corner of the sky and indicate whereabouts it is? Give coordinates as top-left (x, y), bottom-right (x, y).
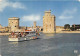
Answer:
top-left (0, 0), bottom-right (26, 12)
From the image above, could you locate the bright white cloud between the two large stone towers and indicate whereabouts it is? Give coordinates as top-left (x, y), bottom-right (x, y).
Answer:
top-left (22, 14), bottom-right (40, 22)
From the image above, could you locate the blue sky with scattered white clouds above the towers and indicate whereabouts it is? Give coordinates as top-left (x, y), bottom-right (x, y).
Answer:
top-left (0, 0), bottom-right (80, 26)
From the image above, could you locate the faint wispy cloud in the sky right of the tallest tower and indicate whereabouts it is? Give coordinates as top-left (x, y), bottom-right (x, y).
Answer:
top-left (59, 8), bottom-right (77, 19)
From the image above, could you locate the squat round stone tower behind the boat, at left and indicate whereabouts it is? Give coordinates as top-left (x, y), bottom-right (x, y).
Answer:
top-left (8, 17), bottom-right (19, 32)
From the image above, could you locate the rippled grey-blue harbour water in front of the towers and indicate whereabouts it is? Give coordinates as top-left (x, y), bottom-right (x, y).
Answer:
top-left (0, 33), bottom-right (80, 56)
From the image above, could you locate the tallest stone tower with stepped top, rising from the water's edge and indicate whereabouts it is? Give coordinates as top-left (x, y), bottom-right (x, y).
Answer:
top-left (43, 10), bottom-right (56, 33)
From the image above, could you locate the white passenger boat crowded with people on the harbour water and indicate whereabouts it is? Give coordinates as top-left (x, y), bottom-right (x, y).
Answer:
top-left (8, 30), bottom-right (38, 41)
